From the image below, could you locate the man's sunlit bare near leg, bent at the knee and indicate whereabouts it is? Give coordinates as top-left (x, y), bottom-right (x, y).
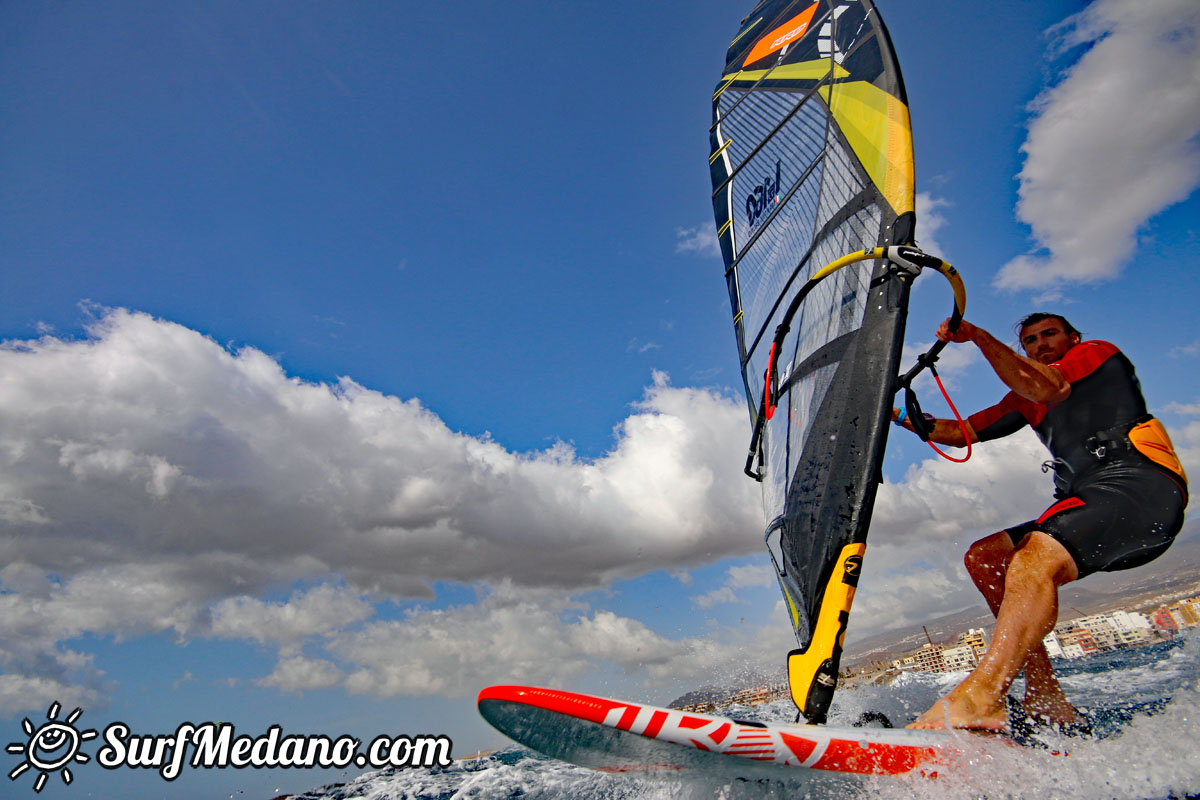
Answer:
top-left (910, 531), bottom-right (1079, 730)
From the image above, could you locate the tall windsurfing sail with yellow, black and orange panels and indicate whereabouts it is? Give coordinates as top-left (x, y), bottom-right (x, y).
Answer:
top-left (709, 0), bottom-right (916, 723)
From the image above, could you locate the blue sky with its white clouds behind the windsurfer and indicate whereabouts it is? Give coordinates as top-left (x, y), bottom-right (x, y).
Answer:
top-left (0, 0), bottom-right (1200, 798)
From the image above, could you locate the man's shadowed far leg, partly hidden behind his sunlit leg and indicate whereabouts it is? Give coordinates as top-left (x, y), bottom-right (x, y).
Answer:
top-left (965, 530), bottom-right (1078, 724)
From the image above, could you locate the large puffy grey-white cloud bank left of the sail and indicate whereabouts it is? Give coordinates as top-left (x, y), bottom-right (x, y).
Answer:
top-left (0, 309), bottom-right (762, 702)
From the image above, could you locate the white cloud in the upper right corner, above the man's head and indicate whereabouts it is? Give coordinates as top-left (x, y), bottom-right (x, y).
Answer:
top-left (996, 0), bottom-right (1200, 289)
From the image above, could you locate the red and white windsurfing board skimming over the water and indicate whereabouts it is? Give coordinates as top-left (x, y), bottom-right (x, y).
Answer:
top-left (479, 686), bottom-right (962, 782)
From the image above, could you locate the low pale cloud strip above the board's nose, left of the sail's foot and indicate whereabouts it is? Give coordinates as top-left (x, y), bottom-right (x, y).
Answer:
top-left (326, 587), bottom-right (787, 697)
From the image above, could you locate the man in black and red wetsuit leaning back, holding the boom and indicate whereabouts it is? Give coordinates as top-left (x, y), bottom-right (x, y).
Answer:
top-left (893, 313), bottom-right (1187, 730)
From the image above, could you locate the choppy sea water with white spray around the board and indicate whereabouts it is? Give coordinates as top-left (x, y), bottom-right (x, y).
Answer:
top-left (292, 628), bottom-right (1200, 800)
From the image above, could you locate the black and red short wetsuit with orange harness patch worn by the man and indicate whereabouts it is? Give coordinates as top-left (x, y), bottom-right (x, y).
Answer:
top-left (968, 342), bottom-right (1188, 577)
